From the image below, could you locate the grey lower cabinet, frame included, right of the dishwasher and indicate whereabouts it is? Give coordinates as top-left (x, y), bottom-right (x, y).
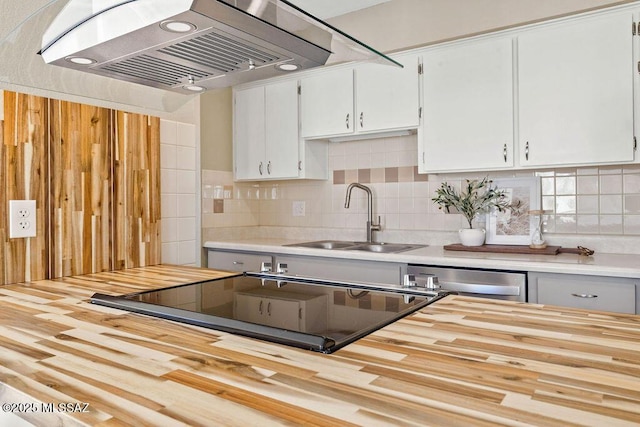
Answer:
top-left (528, 273), bottom-right (640, 314)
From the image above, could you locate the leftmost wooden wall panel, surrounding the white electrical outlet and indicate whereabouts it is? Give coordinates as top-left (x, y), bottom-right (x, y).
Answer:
top-left (0, 91), bottom-right (48, 283)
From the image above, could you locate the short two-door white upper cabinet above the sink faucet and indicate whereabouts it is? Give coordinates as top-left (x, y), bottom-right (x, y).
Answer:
top-left (301, 55), bottom-right (420, 138)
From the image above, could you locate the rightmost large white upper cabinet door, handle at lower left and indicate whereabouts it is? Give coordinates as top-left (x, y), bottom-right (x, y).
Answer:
top-left (518, 12), bottom-right (634, 166)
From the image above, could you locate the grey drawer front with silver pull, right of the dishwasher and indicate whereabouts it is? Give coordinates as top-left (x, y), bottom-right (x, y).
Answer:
top-left (538, 277), bottom-right (636, 314)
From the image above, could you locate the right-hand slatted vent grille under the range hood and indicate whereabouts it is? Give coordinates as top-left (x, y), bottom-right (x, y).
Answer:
top-left (159, 32), bottom-right (283, 73)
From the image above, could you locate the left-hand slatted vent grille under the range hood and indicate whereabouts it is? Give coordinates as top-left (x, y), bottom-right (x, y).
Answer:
top-left (100, 55), bottom-right (211, 87)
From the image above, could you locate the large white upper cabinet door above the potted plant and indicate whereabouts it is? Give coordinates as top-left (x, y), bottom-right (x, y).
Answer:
top-left (418, 38), bottom-right (514, 172)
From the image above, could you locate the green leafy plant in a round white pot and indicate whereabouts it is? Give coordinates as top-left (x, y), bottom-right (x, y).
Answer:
top-left (431, 177), bottom-right (511, 246)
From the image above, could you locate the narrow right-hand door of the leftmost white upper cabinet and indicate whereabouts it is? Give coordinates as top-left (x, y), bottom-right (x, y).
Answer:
top-left (265, 80), bottom-right (299, 178)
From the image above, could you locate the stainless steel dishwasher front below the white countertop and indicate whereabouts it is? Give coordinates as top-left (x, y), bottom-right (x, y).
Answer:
top-left (407, 264), bottom-right (527, 302)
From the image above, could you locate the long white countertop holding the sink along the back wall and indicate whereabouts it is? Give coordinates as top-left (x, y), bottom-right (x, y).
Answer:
top-left (204, 239), bottom-right (640, 278)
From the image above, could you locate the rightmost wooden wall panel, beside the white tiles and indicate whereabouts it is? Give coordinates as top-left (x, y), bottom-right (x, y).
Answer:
top-left (114, 111), bottom-right (161, 269)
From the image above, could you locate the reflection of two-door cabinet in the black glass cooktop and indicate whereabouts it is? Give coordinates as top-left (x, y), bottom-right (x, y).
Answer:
top-left (234, 288), bottom-right (327, 332)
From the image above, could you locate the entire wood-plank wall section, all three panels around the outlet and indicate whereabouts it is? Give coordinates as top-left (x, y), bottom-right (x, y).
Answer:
top-left (0, 91), bottom-right (161, 284)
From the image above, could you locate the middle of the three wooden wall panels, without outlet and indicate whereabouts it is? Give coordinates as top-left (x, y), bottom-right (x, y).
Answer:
top-left (50, 100), bottom-right (113, 278)
